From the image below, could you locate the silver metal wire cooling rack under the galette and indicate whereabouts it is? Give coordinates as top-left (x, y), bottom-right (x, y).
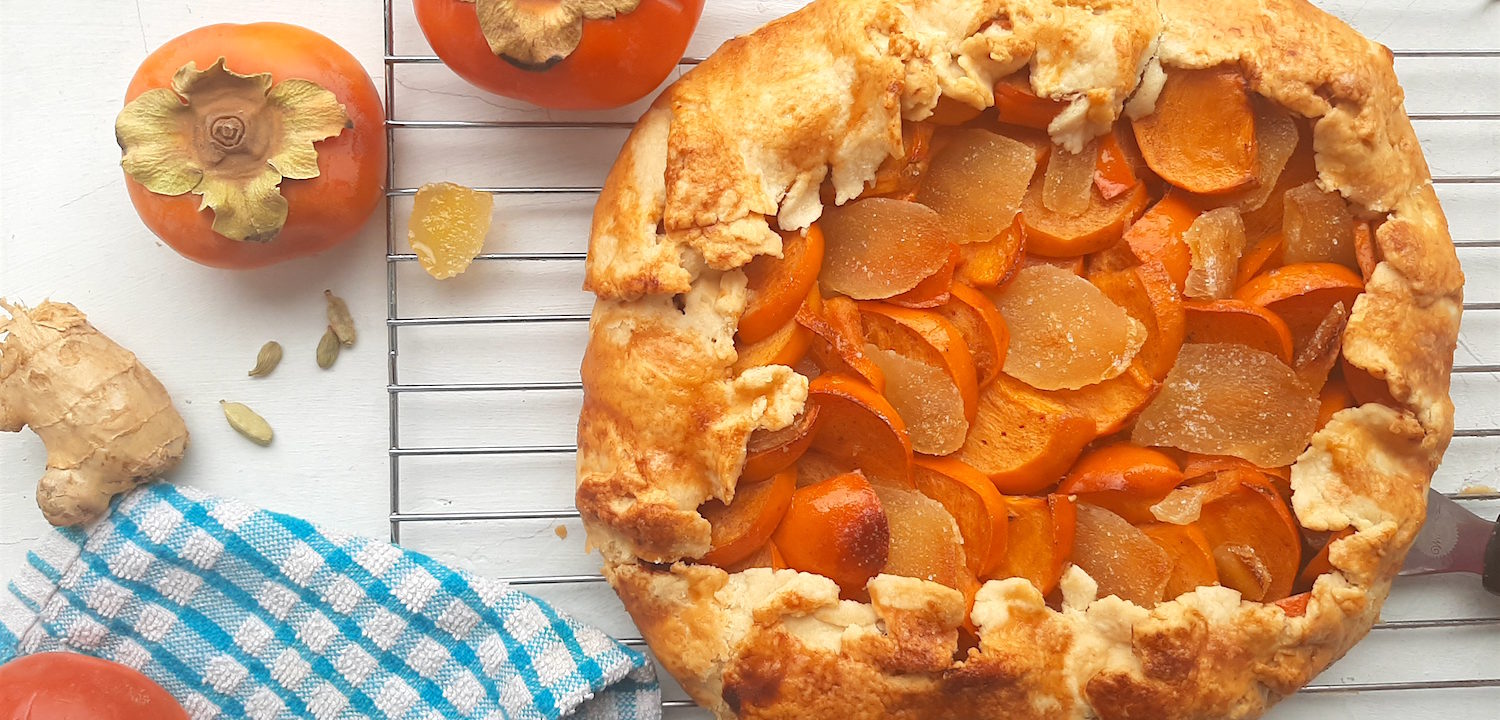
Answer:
top-left (384, 0), bottom-right (1500, 717)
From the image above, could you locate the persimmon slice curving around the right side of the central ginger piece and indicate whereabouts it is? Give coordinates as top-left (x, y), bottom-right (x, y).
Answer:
top-left (1089, 260), bottom-right (1187, 380)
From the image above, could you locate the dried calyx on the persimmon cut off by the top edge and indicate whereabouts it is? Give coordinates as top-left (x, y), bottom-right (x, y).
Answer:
top-left (465, 0), bottom-right (641, 71)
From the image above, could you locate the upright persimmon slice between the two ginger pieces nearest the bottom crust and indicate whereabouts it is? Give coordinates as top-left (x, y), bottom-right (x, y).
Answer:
top-left (993, 495), bottom-right (1079, 596)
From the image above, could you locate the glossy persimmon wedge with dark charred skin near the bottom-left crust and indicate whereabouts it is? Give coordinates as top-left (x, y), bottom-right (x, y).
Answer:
top-left (771, 473), bottom-right (891, 594)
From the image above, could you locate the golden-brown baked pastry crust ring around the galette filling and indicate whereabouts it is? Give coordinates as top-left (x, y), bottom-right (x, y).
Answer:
top-left (578, 0), bottom-right (1463, 719)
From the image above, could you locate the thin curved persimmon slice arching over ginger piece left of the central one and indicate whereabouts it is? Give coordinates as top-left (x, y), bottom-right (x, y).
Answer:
top-left (860, 302), bottom-right (980, 423)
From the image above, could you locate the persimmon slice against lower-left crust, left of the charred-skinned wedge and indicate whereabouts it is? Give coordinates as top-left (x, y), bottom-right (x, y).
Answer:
top-left (698, 468), bottom-right (797, 567)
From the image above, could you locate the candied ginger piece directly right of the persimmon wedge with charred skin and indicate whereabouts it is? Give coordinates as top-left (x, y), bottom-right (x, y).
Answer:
top-left (875, 485), bottom-right (968, 590)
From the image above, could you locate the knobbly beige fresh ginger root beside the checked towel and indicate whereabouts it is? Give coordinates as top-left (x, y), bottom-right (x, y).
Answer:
top-left (0, 300), bottom-right (188, 527)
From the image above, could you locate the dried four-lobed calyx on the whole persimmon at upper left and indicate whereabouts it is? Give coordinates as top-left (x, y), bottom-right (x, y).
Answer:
top-left (114, 57), bottom-right (354, 243)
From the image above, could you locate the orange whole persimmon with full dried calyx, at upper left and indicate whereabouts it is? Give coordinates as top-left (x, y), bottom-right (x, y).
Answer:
top-left (114, 23), bottom-right (387, 269)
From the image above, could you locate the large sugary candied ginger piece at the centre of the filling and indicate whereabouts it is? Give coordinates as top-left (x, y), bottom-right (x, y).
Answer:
top-left (990, 263), bottom-right (1146, 390)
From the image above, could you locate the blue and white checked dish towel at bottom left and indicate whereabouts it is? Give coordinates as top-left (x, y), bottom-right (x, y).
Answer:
top-left (0, 483), bottom-right (662, 720)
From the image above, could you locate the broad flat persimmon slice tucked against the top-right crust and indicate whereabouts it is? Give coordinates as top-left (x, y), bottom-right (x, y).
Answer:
top-left (1133, 66), bottom-right (1257, 194)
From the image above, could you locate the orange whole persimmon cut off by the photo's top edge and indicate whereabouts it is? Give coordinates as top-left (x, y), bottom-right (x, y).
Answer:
top-left (414, 0), bottom-right (704, 110)
